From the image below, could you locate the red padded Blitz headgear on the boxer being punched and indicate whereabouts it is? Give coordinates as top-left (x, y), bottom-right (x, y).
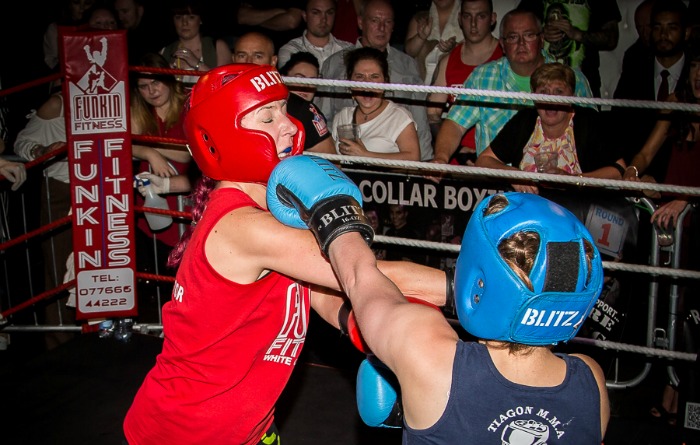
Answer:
top-left (185, 63), bottom-right (304, 183)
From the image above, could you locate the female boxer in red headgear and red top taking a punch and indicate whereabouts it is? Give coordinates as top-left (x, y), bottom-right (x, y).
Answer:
top-left (124, 64), bottom-right (445, 445)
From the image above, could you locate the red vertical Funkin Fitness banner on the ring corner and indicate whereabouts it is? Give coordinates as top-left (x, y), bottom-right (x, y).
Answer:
top-left (61, 31), bottom-right (137, 319)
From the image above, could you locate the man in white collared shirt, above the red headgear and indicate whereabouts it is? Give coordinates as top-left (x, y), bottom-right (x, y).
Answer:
top-left (277, 0), bottom-right (353, 67)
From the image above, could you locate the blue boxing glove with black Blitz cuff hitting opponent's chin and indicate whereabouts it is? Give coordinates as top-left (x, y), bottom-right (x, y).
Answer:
top-left (267, 155), bottom-right (374, 256)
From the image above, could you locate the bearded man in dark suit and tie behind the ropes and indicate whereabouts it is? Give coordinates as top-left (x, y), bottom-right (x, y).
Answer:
top-left (613, 0), bottom-right (691, 173)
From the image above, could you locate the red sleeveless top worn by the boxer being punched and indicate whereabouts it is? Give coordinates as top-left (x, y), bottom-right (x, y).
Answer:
top-left (124, 188), bottom-right (310, 445)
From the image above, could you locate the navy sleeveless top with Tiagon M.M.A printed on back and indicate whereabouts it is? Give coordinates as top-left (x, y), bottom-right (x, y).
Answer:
top-left (403, 341), bottom-right (602, 445)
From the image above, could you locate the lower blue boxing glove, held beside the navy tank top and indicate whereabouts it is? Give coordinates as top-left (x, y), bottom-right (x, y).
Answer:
top-left (356, 356), bottom-right (403, 428)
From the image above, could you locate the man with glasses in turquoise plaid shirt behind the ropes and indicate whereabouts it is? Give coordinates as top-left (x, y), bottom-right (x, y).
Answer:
top-left (433, 9), bottom-right (592, 164)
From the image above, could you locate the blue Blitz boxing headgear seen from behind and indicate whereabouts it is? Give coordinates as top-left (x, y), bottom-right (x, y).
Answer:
top-left (455, 192), bottom-right (603, 346)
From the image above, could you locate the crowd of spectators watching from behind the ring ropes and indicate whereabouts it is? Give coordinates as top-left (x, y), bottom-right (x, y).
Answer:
top-left (0, 0), bottom-right (700, 434)
